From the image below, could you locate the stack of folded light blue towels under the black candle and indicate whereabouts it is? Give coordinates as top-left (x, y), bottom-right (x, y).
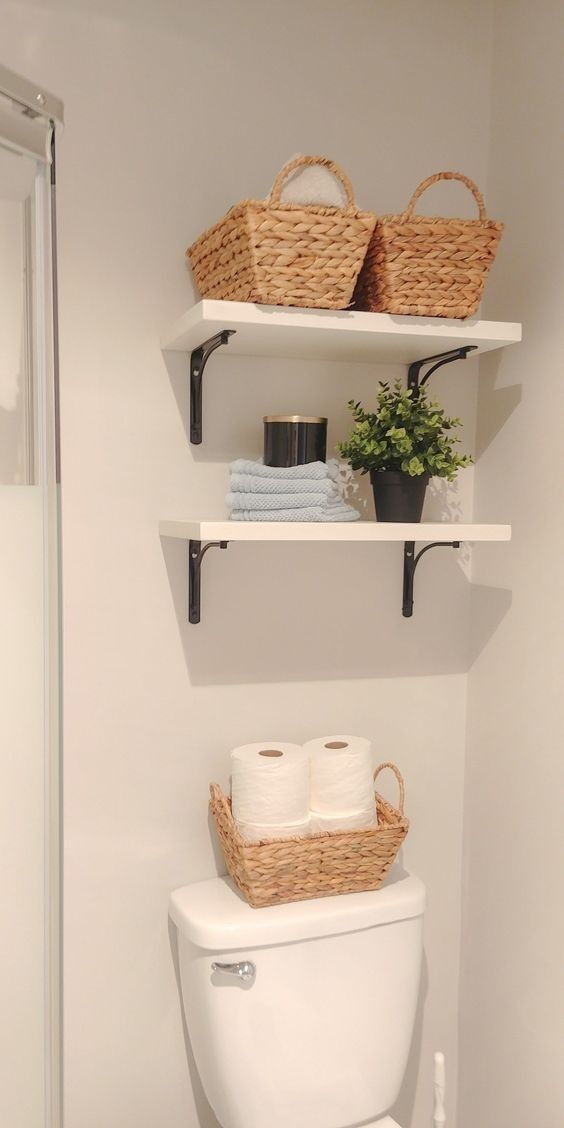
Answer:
top-left (226, 458), bottom-right (360, 521)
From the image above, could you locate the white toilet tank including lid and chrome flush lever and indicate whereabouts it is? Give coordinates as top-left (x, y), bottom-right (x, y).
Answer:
top-left (169, 869), bottom-right (425, 1128)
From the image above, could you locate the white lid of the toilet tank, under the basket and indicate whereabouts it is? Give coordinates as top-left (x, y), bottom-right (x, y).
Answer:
top-left (169, 866), bottom-right (425, 952)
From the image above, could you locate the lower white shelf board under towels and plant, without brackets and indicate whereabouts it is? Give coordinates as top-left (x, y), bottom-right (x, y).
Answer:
top-left (159, 521), bottom-right (511, 544)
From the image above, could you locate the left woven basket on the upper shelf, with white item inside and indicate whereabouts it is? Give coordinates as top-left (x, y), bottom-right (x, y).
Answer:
top-left (186, 157), bottom-right (376, 309)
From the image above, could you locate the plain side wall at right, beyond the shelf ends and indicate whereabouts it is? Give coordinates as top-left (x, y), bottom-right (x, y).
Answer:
top-left (458, 0), bottom-right (564, 1128)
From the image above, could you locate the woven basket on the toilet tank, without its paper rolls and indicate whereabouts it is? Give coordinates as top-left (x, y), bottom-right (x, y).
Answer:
top-left (210, 764), bottom-right (409, 908)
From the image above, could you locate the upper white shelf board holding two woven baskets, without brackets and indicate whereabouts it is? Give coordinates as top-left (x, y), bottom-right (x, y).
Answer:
top-left (161, 300), bottom-right (521, 364)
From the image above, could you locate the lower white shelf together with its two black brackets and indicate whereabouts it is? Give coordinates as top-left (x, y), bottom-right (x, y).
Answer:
top-left (159, 521), bottom-right (511, 624)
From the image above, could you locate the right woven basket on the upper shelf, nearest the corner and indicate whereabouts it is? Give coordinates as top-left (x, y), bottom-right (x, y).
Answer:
top-left (354, 173), bottom-right (503, 317)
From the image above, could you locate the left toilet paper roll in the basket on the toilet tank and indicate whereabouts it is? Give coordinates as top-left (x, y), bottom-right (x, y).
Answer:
top-left (231, 741), bottom-right (309, 827)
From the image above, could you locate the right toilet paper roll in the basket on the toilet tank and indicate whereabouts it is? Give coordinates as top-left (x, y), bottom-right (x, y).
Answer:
top-left (303, 735), bottom-right (376, 822)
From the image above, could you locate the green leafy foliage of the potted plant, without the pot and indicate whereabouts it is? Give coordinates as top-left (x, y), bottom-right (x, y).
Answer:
top-left (337, 380), bottom-right (473, 482)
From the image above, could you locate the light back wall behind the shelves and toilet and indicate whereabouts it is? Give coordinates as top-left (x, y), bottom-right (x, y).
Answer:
top-left (0, 0), bottom-right (494, 1128)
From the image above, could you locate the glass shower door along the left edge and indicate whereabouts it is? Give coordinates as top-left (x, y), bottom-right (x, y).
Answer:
top-left (0, 94), bottom-right (60, 1128)
